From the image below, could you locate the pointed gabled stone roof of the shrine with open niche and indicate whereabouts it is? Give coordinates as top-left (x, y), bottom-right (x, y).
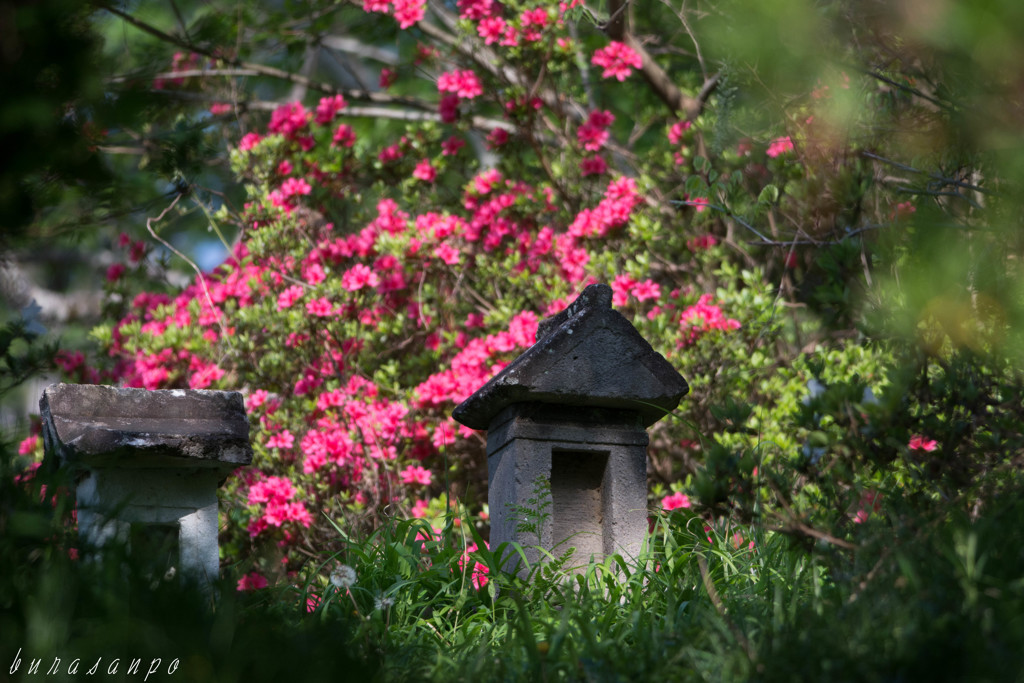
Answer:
top-left (452, 285), bottom-right (689, 429)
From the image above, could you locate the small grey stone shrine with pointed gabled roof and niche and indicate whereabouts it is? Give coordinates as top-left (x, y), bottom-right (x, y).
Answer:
top-left (453, 285), bottom-right (689, 566)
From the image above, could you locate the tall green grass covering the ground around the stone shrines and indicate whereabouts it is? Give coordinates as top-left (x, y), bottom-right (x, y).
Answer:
top-left (6, 444), bottom-right (1024, 683)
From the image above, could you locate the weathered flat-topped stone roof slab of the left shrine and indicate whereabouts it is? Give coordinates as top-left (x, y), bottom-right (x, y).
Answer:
top-left (39, 384), bottom-right (252, 470)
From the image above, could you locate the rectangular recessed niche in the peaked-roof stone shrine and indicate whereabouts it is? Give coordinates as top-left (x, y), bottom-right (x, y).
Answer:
top-left (551, 450), bottom-right (608, 565)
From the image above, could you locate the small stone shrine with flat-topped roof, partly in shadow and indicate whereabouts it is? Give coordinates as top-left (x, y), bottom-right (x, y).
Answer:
top-left (39, 384), bottom-right (252, 586)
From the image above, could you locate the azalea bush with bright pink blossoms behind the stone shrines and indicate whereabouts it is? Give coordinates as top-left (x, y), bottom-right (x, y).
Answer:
top-left (75, 3), bottom-right (823, 573)
